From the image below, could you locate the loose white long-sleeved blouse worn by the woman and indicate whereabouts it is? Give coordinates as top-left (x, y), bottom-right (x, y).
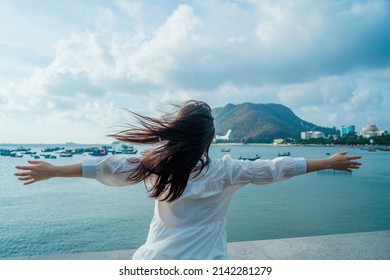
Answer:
top-left (82, 155), bottom-right (306, 260)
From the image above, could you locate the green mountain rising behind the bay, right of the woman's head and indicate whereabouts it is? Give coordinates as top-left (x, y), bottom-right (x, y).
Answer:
top-left (213, 103), bottom-right (338, 142)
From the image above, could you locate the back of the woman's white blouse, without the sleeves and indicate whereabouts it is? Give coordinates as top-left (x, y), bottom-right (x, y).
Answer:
top-left (133, 160), bottom-right (233, 259)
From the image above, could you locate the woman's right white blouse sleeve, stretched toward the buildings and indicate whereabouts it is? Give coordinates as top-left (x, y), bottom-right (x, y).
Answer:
top-left (222, 156), bottom-right (306, 187)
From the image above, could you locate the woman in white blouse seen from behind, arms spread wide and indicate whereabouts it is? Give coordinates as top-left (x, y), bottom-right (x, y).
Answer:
top-left (15, 100), bottom-right (361, 259)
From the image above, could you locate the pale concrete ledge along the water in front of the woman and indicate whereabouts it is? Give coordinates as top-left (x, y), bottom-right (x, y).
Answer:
top-left (3, 230), bottom-right (390, 260)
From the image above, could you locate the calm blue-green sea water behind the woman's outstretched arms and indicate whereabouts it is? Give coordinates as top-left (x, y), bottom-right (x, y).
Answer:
top-left (0, 145), bottom-right (390, 259)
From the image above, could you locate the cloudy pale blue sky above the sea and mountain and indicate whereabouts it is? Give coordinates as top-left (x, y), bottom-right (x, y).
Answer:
top-left (0, 0), bottom-right (390, 143)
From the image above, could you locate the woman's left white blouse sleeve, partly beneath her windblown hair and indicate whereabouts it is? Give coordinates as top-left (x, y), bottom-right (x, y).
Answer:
top-left (82, 156), bottom-right (139, 186)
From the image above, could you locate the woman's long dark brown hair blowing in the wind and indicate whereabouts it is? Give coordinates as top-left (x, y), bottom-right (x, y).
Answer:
top-left (110, 100), bottom-right (215, 202)
